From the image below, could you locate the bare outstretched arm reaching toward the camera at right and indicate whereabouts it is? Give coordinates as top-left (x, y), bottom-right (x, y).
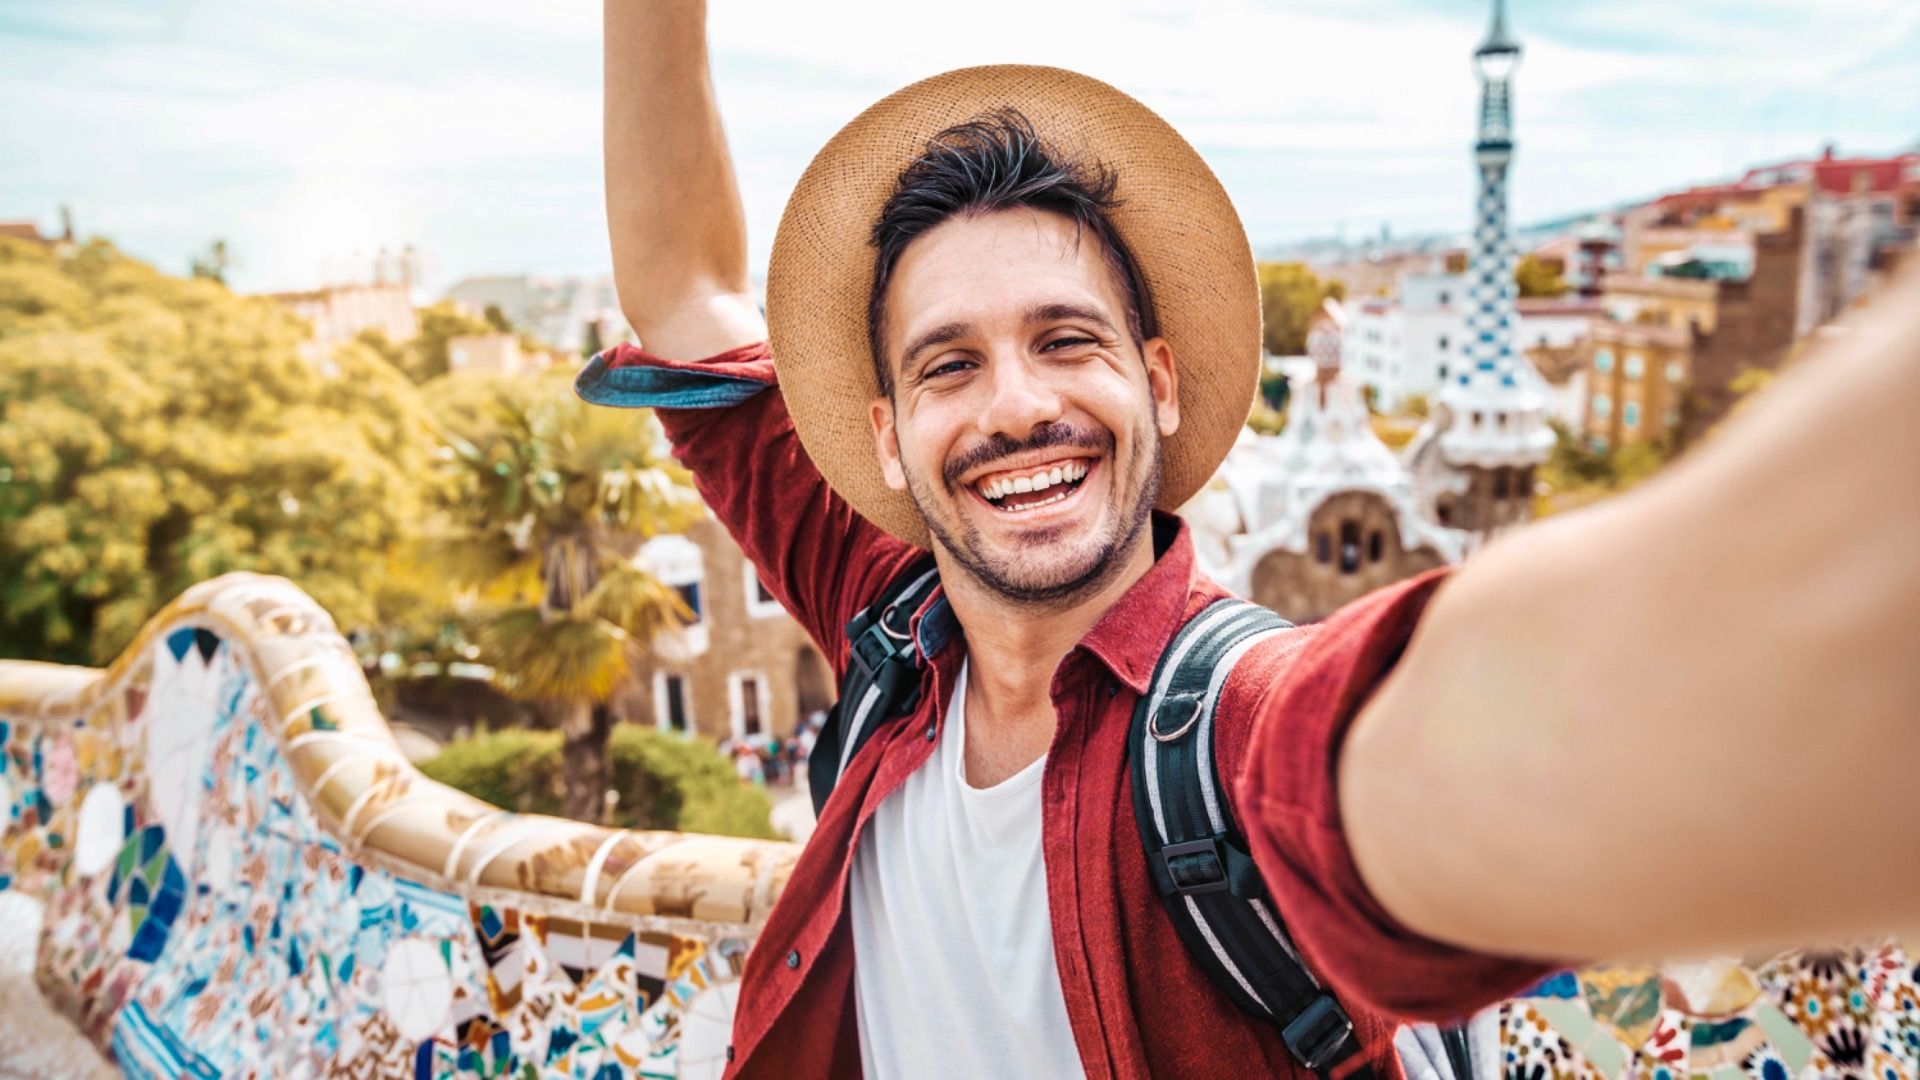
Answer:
top-left (1340, 275), bottom-right (1920, 959)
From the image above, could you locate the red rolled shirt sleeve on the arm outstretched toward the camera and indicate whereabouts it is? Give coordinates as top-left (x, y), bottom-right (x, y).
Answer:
top-left (1238, 571), bottom-right (1553, 1022)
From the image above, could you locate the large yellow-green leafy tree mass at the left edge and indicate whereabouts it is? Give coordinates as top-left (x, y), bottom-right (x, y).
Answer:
top-left (0, 240), bottom-right (434, 663)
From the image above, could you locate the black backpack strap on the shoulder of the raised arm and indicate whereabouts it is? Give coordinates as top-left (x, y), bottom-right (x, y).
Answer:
top-left (806, 559), bottom-right (941, 815)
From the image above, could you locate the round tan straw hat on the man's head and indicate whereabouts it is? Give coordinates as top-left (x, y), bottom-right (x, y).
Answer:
top-left (766, 65), bottom-right (1260, 548)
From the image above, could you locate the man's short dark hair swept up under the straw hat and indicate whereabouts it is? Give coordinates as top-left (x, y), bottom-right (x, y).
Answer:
top-left (866, 108), bottom-right (1158, 394)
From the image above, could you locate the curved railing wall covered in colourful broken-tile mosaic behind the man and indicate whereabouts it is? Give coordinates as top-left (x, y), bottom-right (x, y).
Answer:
top-left (0, 575), bottom-right (1920, 1080)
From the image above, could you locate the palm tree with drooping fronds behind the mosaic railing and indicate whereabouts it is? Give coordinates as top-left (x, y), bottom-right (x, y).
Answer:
top-left (430, 377), bottom-right (703, 821)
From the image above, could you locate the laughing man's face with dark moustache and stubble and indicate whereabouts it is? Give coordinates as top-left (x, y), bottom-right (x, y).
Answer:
top-left (872, 208), bottom-right (1179, 603)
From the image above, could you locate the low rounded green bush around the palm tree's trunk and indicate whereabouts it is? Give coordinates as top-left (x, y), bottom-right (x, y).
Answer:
top-left (420, 724), bottom-right (778, 840)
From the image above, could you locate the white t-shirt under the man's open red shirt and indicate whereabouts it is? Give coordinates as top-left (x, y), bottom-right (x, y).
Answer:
top-left (849, 663), bottom-right (1085, 1080)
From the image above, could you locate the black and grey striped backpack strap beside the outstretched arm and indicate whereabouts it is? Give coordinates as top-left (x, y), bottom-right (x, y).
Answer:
top-left (1129, 598), bottom-right (1373, 1080)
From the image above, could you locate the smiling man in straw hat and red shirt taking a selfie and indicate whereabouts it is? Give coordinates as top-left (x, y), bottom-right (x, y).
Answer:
top-left (580, 0), bottom-right (1920, 1076)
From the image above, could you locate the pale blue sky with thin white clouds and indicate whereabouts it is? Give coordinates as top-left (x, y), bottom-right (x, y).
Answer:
top-left (0, 0), bottom-right (1920, 290)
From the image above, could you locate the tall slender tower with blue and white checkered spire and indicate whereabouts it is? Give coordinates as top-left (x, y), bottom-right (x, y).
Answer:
top-left (1413, 0), bottom-right (1553, 540)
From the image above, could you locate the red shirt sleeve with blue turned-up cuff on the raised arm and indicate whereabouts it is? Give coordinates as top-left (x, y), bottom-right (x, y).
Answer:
top-left (574, 342), bottom-right (918, 671)
